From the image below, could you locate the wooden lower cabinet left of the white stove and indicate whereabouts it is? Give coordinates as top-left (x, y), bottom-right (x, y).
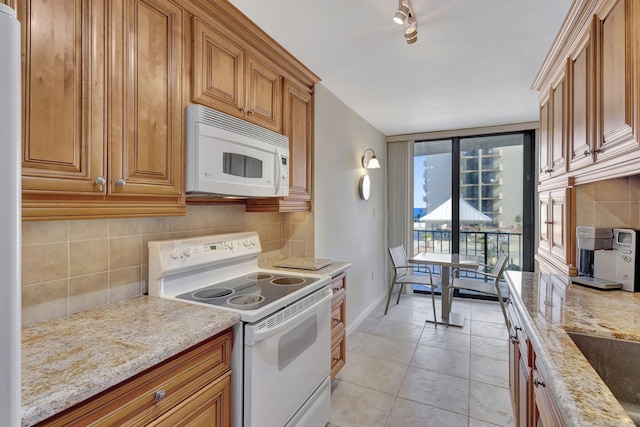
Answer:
top-left (38, 329), bottom-right (232, 427)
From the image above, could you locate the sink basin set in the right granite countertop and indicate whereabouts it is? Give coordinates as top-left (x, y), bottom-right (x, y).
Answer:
top-left (568, 332), bottom-right (640, 426)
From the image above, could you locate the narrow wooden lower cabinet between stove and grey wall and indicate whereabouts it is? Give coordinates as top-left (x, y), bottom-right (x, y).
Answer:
top-left (331, 273), bottom-right (347, 380)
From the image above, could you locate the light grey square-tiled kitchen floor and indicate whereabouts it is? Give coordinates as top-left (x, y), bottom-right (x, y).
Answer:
top-left (328, 294), bottom-right (514, 427)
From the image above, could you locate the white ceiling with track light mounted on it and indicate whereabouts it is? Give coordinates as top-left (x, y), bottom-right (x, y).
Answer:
top-left (230, 0), bottom-right (571, 135)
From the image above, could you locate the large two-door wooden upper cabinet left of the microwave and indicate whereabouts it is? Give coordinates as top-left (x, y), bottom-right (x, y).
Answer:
top-left (17, 0), bottom-right (186, 220)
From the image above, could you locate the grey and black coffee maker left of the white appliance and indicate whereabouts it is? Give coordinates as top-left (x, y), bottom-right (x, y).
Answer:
top-left (571, 226), bottom-right (622, 290)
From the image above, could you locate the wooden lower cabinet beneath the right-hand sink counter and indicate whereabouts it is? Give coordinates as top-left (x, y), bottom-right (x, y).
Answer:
top-left (507, 304), bottom-right (565, 427)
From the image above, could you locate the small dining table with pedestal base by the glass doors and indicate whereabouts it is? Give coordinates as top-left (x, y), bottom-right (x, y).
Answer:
top-left (409, 252), bottom-right (480, 327)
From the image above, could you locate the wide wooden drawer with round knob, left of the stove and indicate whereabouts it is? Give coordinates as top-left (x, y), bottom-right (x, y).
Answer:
top-left (40, 331), bottom-right (232, 426)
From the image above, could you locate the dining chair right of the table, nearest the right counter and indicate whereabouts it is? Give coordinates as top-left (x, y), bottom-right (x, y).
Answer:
top-left (449, 252), bottom-right (509, 328)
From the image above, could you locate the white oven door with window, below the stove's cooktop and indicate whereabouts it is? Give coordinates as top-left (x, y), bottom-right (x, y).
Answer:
top-left (244, 287), bottom-right (332, 427)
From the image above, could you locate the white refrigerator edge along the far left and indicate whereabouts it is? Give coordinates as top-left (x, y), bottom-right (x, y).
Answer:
top-left (0, 4), bottom-right (22, 427)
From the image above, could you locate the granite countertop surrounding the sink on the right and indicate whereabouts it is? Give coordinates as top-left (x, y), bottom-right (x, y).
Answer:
top-left (505, 271), bottom-right (640, 427)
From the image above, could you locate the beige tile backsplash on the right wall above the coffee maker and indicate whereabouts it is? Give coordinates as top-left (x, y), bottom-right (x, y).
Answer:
top-left (576, 175), bottom-right (640, 229)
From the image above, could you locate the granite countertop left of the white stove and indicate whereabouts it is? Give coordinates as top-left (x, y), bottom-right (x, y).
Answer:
top-left (22, 296), bottom-right (240, 426)
